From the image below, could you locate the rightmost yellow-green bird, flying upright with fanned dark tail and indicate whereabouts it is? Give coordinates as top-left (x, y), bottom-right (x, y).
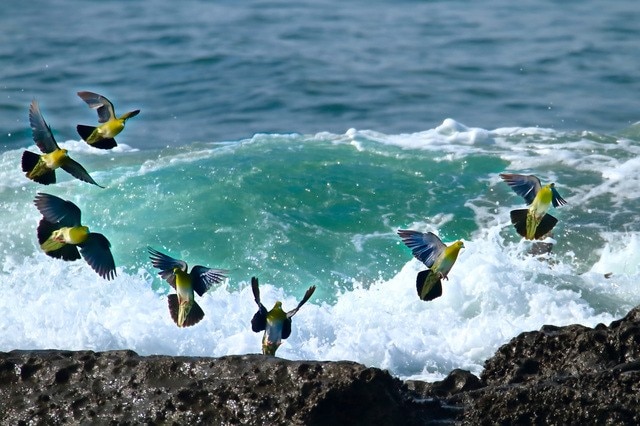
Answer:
top-left (500, 173), bottom-right (567, 240)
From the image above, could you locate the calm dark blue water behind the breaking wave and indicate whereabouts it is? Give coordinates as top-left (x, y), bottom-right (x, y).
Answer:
top-left (0, 0), bottom-right (640, 149)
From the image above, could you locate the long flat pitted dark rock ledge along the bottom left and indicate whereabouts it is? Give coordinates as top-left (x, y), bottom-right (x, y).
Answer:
top-left (0, 351), bottom-right (440, 425)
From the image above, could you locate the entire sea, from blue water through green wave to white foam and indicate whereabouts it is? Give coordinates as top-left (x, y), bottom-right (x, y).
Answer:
top-left (0, 0), bottom-right (640, 381)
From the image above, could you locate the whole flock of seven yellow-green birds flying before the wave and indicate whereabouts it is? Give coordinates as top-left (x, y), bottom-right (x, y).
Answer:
top-left (22, 91), bottom-right (566, 355)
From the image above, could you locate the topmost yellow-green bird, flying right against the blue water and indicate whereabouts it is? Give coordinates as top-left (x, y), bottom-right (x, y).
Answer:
top-left (76, 92), bottom-right (140, 149)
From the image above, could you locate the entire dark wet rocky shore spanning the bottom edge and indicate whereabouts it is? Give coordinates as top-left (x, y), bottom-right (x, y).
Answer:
top-left (0, 308), bottom-right (640, 426)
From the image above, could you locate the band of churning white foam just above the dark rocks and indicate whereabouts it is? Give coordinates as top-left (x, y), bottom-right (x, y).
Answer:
top-left (0, 225), bottom-right (640, 380)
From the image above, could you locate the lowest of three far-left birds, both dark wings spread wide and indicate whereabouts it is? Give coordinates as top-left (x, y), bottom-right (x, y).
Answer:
top-left (34, 193), bottom-right (116, 280)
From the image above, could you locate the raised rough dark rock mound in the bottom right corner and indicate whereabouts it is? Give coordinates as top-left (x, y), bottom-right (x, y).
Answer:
top-left (458, 308), bottom-right (640, 425)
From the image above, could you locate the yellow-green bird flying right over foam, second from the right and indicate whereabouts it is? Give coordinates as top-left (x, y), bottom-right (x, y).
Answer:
top-left (398, 229), bottom-right (464, 302)
